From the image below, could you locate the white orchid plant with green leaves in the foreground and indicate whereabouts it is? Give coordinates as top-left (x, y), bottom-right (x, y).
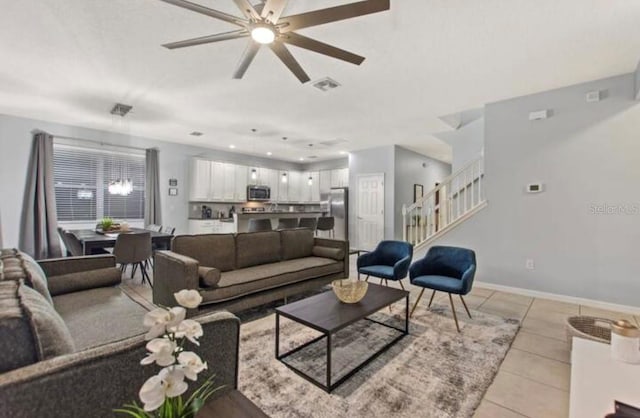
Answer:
top-left (115, 289), bottom-right (222, 418)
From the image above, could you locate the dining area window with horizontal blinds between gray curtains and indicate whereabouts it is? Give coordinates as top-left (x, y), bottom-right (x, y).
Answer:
top-left (53, 143), bottom-right (145, 222)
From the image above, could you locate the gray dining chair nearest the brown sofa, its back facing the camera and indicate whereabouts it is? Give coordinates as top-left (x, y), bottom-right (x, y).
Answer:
top-left (113, 231), bottom-right (153, 287)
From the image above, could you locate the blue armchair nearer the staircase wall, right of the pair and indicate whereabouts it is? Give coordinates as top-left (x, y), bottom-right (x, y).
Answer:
top-left (409, 246), bottom-right (476, 332)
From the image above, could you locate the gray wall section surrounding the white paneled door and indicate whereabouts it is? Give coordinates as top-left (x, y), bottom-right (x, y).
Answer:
top-left (349, 145), bottom-right (395, 247)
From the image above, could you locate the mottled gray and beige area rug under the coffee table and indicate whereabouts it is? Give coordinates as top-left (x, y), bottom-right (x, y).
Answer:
top-left (239, 303), bottom-right (519, 418)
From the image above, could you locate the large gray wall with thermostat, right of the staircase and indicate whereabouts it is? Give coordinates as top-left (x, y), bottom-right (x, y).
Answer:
top-left (428, 74), bottom-right (640, 306)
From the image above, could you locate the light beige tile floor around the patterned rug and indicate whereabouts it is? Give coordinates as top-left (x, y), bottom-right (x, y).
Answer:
top-left (123, 257), bottom-right (640, 418)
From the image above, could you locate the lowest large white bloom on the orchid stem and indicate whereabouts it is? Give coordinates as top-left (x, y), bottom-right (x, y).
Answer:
top-left (139, 367), bottom-right (188, 412)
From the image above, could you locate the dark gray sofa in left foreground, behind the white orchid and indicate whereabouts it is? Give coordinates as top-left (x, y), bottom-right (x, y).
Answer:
top-left (0, 250), bottom-right (240, 418)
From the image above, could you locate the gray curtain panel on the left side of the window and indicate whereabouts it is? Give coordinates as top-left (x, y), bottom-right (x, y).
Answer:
top-left (20, 132), bottom-right (62, 260)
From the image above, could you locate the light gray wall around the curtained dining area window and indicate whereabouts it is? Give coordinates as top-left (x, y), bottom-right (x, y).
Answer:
top-left (0, 115), bottom-right (303, 247)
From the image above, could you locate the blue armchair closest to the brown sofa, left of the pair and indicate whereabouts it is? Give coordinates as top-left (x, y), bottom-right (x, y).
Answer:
top-left (358, 241), bottom-right (413, 289)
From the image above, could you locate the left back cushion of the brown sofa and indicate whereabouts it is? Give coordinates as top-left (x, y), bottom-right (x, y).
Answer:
top-left (171, 234), bottom-right (236, 271)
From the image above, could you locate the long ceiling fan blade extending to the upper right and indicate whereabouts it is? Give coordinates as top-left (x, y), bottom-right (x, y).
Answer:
top-left (278, 0), bottom-right (390, 33)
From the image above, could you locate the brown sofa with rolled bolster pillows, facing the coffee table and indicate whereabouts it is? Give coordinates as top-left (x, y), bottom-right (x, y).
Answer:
top-left (153, 228), bottom-right (349, 312)
